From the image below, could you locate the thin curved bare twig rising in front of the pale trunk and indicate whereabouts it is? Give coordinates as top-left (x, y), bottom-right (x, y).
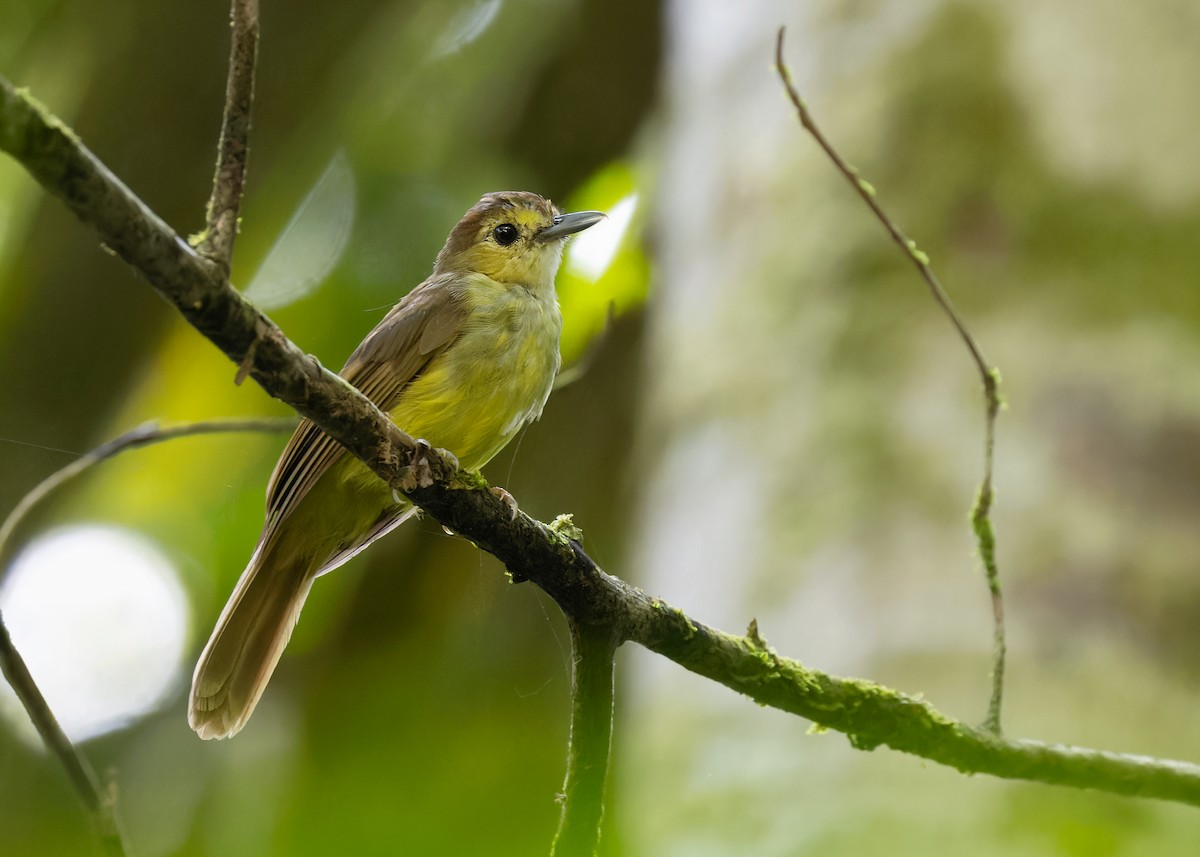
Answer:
top-left (775, 26), bottom-right (1006, 733)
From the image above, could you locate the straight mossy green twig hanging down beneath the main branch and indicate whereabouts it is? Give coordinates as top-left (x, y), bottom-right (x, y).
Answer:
top-left (551, 616), bottom-right (617, 857)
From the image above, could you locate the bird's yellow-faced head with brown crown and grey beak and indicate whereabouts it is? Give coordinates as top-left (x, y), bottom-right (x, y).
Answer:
top-left (433, 191), bottom-right (604, 292)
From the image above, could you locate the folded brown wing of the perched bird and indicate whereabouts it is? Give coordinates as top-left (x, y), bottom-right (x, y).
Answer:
top-left (262, 275), bottom-right (467, 528)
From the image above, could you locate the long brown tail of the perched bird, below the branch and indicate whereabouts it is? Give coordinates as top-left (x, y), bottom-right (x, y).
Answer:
top-left (187, 539), bottom-right (314, 738)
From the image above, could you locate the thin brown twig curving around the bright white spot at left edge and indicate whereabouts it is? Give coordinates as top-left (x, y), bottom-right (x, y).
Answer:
top-left (0, 419), bottom-right (295, 855)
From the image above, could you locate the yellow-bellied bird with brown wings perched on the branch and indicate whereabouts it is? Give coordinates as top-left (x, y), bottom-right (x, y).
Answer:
top-left (187, 192), bottom-right (604, 738)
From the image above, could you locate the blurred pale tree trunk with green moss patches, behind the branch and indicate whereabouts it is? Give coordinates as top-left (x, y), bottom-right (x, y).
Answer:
top-left (616, 2), bottom-right (1200, 857)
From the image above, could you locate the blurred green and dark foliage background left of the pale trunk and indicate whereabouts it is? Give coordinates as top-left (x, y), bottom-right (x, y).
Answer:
top-left (0, 0), bottom-right (660, 855)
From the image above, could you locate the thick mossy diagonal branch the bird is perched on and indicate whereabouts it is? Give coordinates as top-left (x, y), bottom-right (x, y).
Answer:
top-left (0, 71), bottom-right (1200, 807)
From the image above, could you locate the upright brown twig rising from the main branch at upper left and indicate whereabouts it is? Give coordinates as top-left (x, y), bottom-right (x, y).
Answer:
top-left (199, 0), bottom-right (258, 275)
